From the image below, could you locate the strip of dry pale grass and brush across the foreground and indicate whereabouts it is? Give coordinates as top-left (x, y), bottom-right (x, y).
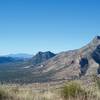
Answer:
top-left (0, 78), bottom-right (100, 100)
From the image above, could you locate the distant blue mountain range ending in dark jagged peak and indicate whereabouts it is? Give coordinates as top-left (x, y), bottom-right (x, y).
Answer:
top-left (0, 51), bottom-right (56, 66)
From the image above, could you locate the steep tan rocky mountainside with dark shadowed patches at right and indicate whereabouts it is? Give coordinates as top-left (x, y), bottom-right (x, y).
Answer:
top-left (37, 36), bottom-right (100, 80)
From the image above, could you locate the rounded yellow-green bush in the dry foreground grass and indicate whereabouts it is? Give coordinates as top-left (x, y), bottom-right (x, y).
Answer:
top-left (62, 82), bottom-right (87, 99)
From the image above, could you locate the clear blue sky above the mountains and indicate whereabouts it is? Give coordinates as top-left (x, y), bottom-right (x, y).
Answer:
top-left (0, 0), bottom-right (100, 55)
